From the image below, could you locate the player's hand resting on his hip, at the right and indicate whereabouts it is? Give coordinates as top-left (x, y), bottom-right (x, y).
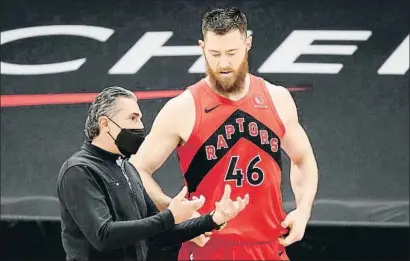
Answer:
top-left (279, 209), bottom-right (310, 247)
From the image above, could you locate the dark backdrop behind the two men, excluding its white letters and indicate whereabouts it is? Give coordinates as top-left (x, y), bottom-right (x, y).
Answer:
top-left (1, 0), bottom-right (410, 259)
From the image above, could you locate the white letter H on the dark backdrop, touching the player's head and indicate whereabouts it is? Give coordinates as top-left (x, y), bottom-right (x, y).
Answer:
top-left (108, 32), bottom-right (202, 74)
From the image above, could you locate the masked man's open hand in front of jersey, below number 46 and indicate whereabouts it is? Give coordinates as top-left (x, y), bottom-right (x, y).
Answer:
top-left (212, 185), bottom-right (249, 225)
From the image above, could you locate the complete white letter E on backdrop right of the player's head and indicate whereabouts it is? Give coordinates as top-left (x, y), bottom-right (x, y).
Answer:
top-left (258, 30), bottom-right (372, 74)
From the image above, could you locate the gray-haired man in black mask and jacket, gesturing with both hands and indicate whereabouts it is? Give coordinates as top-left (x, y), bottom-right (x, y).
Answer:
top-left (57, 87), bottom-right (249, 261)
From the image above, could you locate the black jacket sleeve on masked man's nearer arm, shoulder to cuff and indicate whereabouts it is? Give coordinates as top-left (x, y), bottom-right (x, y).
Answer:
top-left (58, 166), bottom-right (175, 251)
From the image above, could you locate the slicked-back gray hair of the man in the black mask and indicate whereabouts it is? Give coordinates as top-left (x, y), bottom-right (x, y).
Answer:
top-left (84, 86), bottom-right (136, 141)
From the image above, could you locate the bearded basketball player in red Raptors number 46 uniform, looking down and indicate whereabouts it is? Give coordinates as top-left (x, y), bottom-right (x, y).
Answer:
top-left (131, 8), bottom-right (318, 260)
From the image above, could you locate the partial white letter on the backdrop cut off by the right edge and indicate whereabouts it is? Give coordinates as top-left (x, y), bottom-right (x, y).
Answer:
top-left (377, 35), bottom-right (410, 75)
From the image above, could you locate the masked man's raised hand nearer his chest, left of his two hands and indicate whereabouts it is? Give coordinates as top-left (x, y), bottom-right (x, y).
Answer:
top-left (168, 186), bottom-right (205, 224)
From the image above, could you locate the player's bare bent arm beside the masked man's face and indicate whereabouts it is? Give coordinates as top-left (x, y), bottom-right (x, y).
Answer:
top-left (130, 97), bottom-right (181, 211)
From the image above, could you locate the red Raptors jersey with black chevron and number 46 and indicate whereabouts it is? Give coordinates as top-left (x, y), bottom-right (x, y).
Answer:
top-left (177, 75), bottom-right (287, 244)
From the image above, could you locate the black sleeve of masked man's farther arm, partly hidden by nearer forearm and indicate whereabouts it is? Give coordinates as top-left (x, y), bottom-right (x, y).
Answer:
top-left (144, 190), bottom-right (217, 248)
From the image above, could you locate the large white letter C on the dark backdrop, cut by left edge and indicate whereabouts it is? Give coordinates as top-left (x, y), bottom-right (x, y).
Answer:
top-left (1, 25), bottom-right (114, 75)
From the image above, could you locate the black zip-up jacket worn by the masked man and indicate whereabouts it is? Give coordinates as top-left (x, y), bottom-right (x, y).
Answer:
top-left (57, 142), bottom-right (216, 261)
